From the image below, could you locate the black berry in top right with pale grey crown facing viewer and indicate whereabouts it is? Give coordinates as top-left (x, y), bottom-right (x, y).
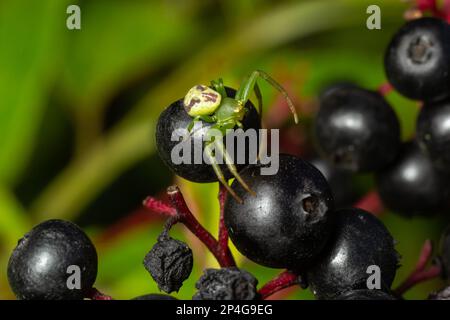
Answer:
top-left (384, 18), bottom-right (450, 100)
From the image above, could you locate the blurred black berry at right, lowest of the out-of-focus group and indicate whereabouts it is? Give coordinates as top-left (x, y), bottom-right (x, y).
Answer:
top-left (376, 142), bottom-right (450, 216)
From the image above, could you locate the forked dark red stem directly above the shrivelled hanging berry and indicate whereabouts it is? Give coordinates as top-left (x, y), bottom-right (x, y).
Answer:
top-left (144, 186), bottom-right (236, 267)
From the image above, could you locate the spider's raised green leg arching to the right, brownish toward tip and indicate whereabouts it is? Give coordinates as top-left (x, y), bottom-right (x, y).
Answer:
top-left (235, 70), bottom-right (298, 123)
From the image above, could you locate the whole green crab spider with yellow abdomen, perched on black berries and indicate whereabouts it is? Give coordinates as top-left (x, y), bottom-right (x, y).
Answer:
top-left (183, 70), bottom-right (298, 203)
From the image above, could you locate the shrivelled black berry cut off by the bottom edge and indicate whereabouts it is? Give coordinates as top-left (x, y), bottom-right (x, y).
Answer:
top-left (193, 268), bottom-right (258, 300)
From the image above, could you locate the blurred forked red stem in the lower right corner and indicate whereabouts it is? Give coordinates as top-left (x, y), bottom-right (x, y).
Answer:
top-left (394, 240), bottom-right (442, 296)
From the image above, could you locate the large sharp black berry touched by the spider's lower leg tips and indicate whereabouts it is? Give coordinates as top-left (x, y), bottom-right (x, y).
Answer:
top-left (224, 154), bottom-right (334, 269)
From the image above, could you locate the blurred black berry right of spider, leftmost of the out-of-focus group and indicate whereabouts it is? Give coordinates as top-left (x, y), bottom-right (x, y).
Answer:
top-left (314, 86), bottom-right (400, 172)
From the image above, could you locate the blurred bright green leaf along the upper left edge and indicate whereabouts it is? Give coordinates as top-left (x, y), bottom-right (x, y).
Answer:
top-left (0, 0), bottom-right (66, 184)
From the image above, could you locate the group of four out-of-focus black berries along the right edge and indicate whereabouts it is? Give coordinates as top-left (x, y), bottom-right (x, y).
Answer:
top-left (315, 18), bottom-right (450, 216)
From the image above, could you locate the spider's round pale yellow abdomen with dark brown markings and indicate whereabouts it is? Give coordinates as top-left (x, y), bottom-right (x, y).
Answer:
top-left (183, 85), bottom-right (222, 117)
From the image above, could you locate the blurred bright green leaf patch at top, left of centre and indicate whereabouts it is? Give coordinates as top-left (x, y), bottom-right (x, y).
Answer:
top-left (63, 1), bottom-right (197, 112)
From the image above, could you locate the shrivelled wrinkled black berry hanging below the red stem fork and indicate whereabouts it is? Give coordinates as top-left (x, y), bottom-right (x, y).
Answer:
top-left (144, 232), bottom-right (193, 293)
